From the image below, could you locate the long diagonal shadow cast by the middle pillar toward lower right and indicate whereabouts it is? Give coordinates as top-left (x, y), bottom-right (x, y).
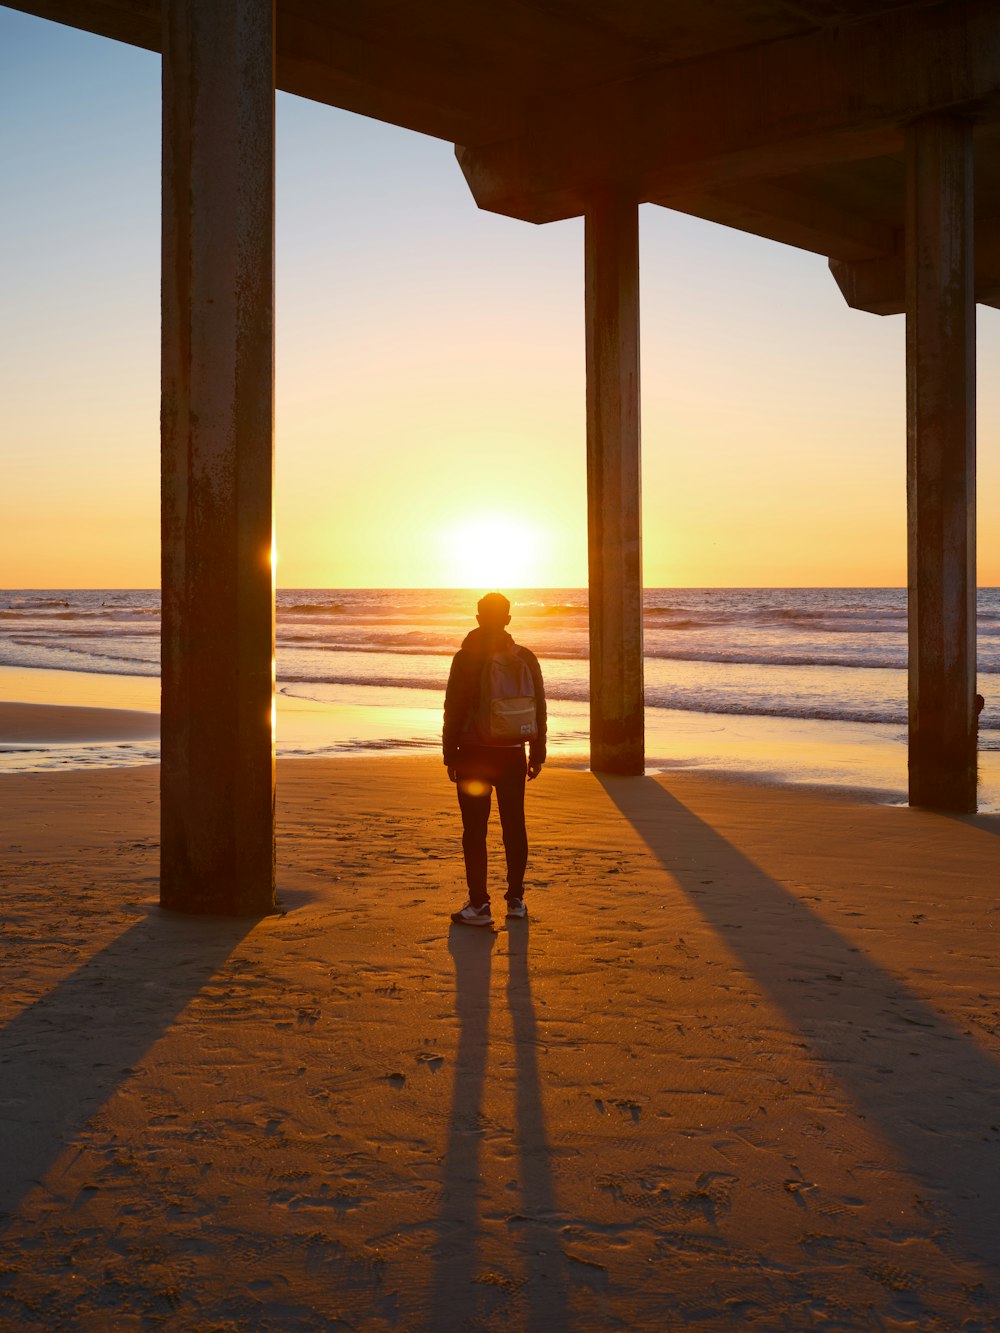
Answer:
top-left (600, 777), bottom-right (1000, 1282)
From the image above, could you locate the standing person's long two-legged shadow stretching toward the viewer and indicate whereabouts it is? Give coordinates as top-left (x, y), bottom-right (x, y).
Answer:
top-left (429, 921), bottom-right (569, 1333)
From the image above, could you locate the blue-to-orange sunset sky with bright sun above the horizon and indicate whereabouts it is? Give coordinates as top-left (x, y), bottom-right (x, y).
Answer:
top-left (0, 9), bottom-right (1000, 588)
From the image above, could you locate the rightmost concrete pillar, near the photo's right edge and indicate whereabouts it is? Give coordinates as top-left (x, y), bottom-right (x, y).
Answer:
top-left (905, 116), bottom-right (976, 810)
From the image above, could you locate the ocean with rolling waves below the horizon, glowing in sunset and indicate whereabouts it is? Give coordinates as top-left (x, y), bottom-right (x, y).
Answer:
top-left (0, 588), bottom-right (1000, 790)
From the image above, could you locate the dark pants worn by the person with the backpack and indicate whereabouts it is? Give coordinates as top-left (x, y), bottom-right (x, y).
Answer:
top-left (456, 745), bottom-right (528, 908)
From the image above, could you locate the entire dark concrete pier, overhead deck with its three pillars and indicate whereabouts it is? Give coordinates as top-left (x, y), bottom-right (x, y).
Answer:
top-left (7, 0), bottom-right (1000, 913)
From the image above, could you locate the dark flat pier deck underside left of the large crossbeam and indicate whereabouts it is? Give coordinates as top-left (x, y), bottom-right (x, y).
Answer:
top-left (13, 0), bottom-right (938, 153)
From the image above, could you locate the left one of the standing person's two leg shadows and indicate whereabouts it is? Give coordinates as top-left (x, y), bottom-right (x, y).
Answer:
top-left (429, 925), bottom-right (496, 1333)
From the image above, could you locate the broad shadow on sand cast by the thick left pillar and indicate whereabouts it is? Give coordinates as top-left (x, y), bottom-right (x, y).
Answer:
top-left (0, 909), bottom-right (255, 1228)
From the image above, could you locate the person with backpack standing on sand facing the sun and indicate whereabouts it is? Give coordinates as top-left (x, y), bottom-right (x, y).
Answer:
top-left (441, 592), bottom-right (547, 926)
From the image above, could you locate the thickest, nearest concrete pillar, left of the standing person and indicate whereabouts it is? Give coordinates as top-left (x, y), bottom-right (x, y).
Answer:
top-left (160, 0), bottom-right (275, 916)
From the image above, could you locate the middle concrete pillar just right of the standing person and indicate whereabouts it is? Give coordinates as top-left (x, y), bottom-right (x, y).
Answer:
top-left (584, 196), bottom-right (645, 773)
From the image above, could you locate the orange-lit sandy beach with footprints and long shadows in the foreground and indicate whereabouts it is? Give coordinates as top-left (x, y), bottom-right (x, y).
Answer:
top-left (0, 725), bottom-right (1000, 1333)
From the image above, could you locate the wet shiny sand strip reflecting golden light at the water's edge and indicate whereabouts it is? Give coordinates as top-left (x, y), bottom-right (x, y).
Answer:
top-left (7, 667), bottom-right (1000, 812)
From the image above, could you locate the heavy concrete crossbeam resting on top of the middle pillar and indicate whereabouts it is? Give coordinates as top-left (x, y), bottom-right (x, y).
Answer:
top-left (459, 0), bottom-right (1000, 223)
